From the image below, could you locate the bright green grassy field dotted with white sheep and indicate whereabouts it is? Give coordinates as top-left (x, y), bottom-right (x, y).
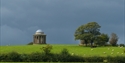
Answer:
top-left (0, 44), bottom-right (125, 56)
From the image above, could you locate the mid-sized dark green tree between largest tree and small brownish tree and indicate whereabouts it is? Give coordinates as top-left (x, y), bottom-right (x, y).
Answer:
top-left (94, 33), bottom-right (109, 46)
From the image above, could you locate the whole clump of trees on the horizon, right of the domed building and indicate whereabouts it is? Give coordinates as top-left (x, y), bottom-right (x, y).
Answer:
top-left (74, 22), bottom-right (124, 47)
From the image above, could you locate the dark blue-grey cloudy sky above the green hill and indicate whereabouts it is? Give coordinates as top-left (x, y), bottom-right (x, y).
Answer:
top-left (0, 0), bottom-right (125, 45)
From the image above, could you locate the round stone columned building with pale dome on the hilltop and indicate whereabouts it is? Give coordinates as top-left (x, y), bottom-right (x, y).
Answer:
top-left (33, 29), bottom-right (46, 44)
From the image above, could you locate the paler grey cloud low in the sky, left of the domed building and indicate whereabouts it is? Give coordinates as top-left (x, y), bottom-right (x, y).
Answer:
top-left (1, 25), bottom-right (29, 45)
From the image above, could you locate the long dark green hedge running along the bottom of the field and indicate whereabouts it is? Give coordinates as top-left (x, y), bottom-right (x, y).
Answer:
top-left (0, 49), bottom-right (125, 63)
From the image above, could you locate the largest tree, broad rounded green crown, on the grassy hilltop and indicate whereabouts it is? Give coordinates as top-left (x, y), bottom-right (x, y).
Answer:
top-left (74, 22), bottom-right (101, 46)
